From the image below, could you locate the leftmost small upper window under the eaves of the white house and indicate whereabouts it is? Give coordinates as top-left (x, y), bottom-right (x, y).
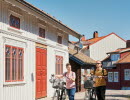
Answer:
top-left (10, 15), bottom-right (20, 29)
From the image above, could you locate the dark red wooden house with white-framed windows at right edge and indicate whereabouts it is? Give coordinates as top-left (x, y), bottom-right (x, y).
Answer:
top-left (103, 42), bottom-right (130, 90)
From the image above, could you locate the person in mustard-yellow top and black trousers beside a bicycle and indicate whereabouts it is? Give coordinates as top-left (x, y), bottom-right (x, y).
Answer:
top-left (91, 61), bottom-right (107, 100)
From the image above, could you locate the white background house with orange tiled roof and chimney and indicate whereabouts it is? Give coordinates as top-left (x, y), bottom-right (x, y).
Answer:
top-left (77, 31), bottom-right (126, 61)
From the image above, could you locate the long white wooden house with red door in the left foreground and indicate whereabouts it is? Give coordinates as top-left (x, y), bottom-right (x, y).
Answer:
top-left (0, 0), bottom-right (81, 100)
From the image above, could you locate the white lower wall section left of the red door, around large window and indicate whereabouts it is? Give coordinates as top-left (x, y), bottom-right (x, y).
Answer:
top-left (0, 33), bottom-right (35, 100)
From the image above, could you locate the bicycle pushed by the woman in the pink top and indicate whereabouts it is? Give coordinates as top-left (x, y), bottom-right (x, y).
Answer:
top-left (50, 74), bottom-right (67, 100)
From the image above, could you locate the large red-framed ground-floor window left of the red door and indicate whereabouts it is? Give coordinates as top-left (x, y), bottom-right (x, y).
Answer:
top-left (5, 45), bottom-right (24, 82)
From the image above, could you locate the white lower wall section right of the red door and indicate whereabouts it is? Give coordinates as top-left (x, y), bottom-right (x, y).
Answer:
top-left (47, 47), bottom-right (68, 97)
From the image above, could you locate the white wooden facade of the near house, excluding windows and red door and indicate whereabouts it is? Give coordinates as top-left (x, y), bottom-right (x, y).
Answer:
top-left (0, 0), bottom-right (69, 100)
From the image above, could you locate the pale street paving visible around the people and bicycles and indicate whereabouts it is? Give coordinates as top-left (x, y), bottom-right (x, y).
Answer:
top-left (39, 90), bottom-right (130, 100)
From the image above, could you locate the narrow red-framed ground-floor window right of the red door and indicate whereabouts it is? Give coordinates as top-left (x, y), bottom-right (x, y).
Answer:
top-left (56, 55), bottom-right (63, 74)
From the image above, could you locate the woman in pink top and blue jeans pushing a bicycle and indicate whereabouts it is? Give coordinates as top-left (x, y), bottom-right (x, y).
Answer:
top-left (55, 63), bottom-right (76, 100)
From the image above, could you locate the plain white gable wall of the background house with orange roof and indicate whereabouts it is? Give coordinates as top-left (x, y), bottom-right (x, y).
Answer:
top-left (90, 34), bottom-right (126, 60)
